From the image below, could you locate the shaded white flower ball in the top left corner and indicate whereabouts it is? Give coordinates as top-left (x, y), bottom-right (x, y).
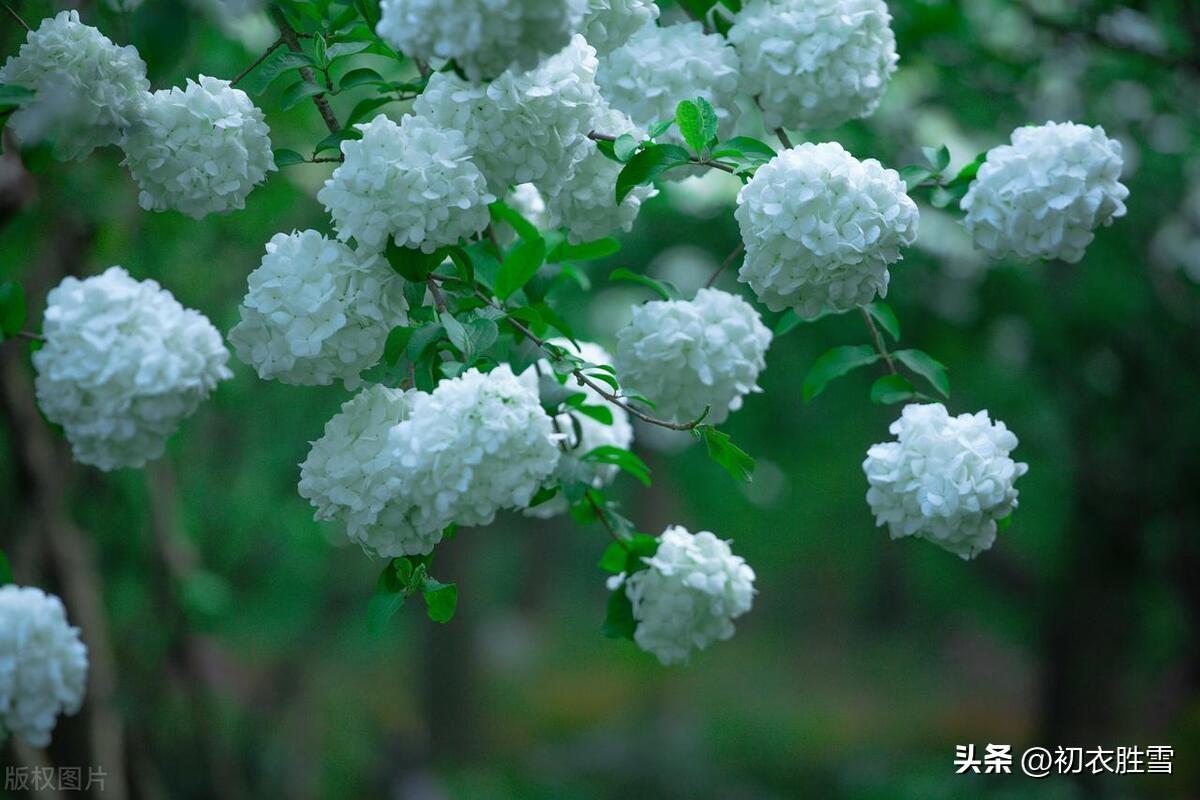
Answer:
top-left (0, 10), bottom-right (150, 161)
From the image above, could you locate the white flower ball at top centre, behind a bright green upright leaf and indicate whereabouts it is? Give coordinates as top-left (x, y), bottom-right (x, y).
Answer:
top-left (596, 22), bottom-right (740, 144)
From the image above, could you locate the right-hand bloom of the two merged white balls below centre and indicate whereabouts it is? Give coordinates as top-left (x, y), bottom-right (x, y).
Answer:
top-left (390, 365), bottom-right (559, 530)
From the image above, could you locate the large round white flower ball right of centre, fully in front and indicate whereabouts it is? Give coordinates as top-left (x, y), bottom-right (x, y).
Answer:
top-left (736, 143), bottom-right (918, 319)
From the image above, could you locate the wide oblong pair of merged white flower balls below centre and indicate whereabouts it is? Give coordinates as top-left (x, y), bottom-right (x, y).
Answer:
top-left (299, 365), bottom-right (559, 558)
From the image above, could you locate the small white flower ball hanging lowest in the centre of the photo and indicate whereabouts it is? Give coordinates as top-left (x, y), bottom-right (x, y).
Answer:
top-left (610, 525), bottom-right (755, 664)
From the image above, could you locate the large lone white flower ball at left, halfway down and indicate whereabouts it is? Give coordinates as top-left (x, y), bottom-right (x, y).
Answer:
top-left (34, 266), bottom-right (233, 471)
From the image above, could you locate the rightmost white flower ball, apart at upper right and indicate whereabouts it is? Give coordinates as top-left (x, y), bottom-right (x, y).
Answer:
top-left (962, 122), bottom-right (1129, 263)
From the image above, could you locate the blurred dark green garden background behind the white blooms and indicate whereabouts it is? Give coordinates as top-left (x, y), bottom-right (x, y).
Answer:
top-left (0, 0), bottom-right (1200, 800)
